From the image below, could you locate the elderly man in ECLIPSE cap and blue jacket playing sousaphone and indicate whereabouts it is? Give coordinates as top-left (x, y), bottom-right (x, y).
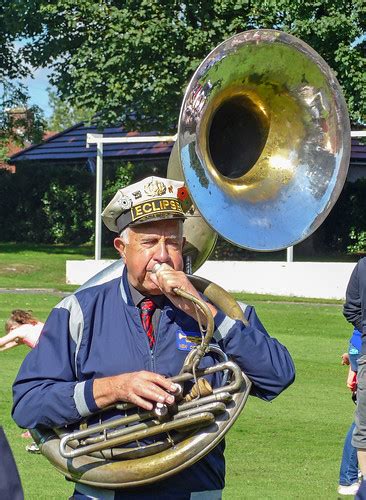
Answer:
top-left (13, 177), bottom-right (294, 500)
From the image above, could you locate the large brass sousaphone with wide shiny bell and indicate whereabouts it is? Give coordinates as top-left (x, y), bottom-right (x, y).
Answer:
top-left (32, 30), bottom-right (350, 488)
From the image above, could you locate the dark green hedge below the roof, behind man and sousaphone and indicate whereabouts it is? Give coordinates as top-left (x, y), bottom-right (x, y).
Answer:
top-left (0, 162), bottom-right (366, 260)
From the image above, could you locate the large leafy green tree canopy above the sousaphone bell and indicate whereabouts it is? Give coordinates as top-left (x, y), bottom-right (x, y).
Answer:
top-left (3, 0), bottom-right (366, 131)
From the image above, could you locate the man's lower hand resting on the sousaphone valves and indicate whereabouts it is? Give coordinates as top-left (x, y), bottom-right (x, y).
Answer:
top-left (93, 371), bottom-right (176, 410)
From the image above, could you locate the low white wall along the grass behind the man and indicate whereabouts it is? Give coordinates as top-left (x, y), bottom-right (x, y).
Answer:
top-left (66, 260), bottom-right (355, 300)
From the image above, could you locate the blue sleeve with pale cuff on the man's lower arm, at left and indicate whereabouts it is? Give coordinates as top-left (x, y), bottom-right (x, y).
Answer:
top-left (12, 298), bottom-right (95, 429)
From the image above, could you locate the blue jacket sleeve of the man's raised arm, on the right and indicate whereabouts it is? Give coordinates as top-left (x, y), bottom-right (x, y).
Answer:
top-left (214, 306), bottom-right (295, 401)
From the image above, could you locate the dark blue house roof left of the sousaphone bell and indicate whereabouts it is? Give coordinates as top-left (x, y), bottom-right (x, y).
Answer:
top-left (9, 122), bottom-right (173, 165)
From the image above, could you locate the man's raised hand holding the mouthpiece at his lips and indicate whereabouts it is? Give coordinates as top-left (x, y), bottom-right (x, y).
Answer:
top-left (150, 264), bottom-right (217, 323)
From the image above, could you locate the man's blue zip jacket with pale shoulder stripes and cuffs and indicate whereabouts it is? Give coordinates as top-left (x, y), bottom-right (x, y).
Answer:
top-left (13, 271), bottom-right (295, 493)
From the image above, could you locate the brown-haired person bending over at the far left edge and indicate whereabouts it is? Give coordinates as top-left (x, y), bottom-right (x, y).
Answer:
top-left (0, 309), bottom-right (44, 351)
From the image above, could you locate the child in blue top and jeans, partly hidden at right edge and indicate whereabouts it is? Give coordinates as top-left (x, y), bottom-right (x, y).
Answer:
top-left (338, 329), bottom-right (361, 496)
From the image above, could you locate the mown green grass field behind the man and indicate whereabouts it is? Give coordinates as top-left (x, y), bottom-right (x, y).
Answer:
top-left (0, 245), bottom-right (354, 500)
